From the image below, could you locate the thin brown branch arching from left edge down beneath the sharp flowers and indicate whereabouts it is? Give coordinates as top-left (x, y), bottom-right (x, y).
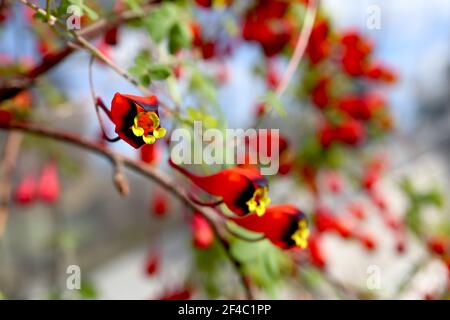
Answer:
top-left (0, 122), bottom-right (253, 299)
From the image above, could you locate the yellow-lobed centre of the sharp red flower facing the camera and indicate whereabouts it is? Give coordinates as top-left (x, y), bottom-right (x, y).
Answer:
top-left (131, 111), bottom-right (166, 144)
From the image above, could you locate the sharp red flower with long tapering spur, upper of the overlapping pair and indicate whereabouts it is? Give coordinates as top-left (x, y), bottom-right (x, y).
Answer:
top-left (169, 159), bottom-right (270, 216)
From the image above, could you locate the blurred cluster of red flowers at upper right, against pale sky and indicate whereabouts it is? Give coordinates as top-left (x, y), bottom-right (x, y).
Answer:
top-left (306, 18), bottom-right (396, 148)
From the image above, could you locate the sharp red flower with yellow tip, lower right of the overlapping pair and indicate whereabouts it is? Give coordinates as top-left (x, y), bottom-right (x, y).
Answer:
top-left (230, 204), bottom-right (309, 249)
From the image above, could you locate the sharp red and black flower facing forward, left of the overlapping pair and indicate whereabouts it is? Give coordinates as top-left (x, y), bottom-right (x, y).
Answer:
top-left (111, 93), bottom-right (166, 149)
